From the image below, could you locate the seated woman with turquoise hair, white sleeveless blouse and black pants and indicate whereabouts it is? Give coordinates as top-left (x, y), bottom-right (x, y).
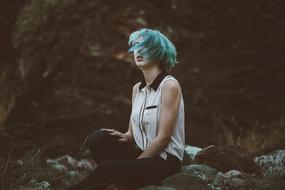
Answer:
top-left (70, 29), bottom-right (185, 190)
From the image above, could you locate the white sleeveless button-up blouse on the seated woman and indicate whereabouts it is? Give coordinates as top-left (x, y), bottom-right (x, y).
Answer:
top-left (131, 74), bottom-right (185, 160)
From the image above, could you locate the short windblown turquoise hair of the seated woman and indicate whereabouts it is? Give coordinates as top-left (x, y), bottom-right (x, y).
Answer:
top-left (128, 28), bottom-right (177, 70)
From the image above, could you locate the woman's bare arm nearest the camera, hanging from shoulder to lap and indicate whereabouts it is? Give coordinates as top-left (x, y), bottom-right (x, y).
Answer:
top-left (138, 80), bottom-right (181, 158)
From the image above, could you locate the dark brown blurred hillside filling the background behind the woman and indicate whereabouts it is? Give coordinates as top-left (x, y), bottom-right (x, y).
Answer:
top-left (0, 0), bottom-right (285, 163)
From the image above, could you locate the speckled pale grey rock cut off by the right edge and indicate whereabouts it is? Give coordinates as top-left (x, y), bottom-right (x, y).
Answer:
top-left (254, 150), bottom-right (285, 177)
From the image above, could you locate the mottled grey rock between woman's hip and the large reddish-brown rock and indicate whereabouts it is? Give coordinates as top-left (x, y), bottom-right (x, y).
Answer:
top-left (182, 164), bottom-right (218, 183)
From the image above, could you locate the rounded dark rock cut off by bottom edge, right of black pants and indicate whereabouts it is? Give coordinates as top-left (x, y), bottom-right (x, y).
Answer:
top-left (162, 172), bottom-right (210, 190)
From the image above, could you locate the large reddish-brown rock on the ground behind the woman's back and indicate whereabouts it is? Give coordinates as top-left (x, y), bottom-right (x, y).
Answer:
top-left (195, 145), bottom-right (261, 175)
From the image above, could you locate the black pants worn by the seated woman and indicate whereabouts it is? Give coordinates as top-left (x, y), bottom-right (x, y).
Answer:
top-left (68, 129), bottom-right (181, 190)
